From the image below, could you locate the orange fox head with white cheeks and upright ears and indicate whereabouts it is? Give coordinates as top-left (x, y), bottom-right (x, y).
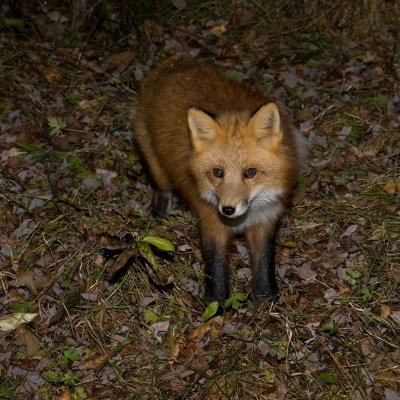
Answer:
top-left (188, 103), bottom-right (287, 223)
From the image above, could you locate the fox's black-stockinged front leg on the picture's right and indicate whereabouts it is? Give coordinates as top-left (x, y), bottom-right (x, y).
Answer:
top-left (246, 224), bottom-right (278, 298)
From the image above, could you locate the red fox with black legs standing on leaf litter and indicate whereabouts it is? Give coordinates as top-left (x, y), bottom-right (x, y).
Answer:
top-left (134, 60), bottom-right (307, 304)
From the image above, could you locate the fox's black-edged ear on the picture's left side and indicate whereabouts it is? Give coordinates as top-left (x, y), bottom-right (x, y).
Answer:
top-left (188, 107), bottom-right (220, 151)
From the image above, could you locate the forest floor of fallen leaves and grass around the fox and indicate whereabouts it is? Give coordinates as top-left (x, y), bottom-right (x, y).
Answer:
top-left (0, 0), bottom-right (400, 400)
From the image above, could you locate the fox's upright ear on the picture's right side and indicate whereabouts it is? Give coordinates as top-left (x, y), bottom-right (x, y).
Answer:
top-left (248, 103), bottom-right (282, 146)
